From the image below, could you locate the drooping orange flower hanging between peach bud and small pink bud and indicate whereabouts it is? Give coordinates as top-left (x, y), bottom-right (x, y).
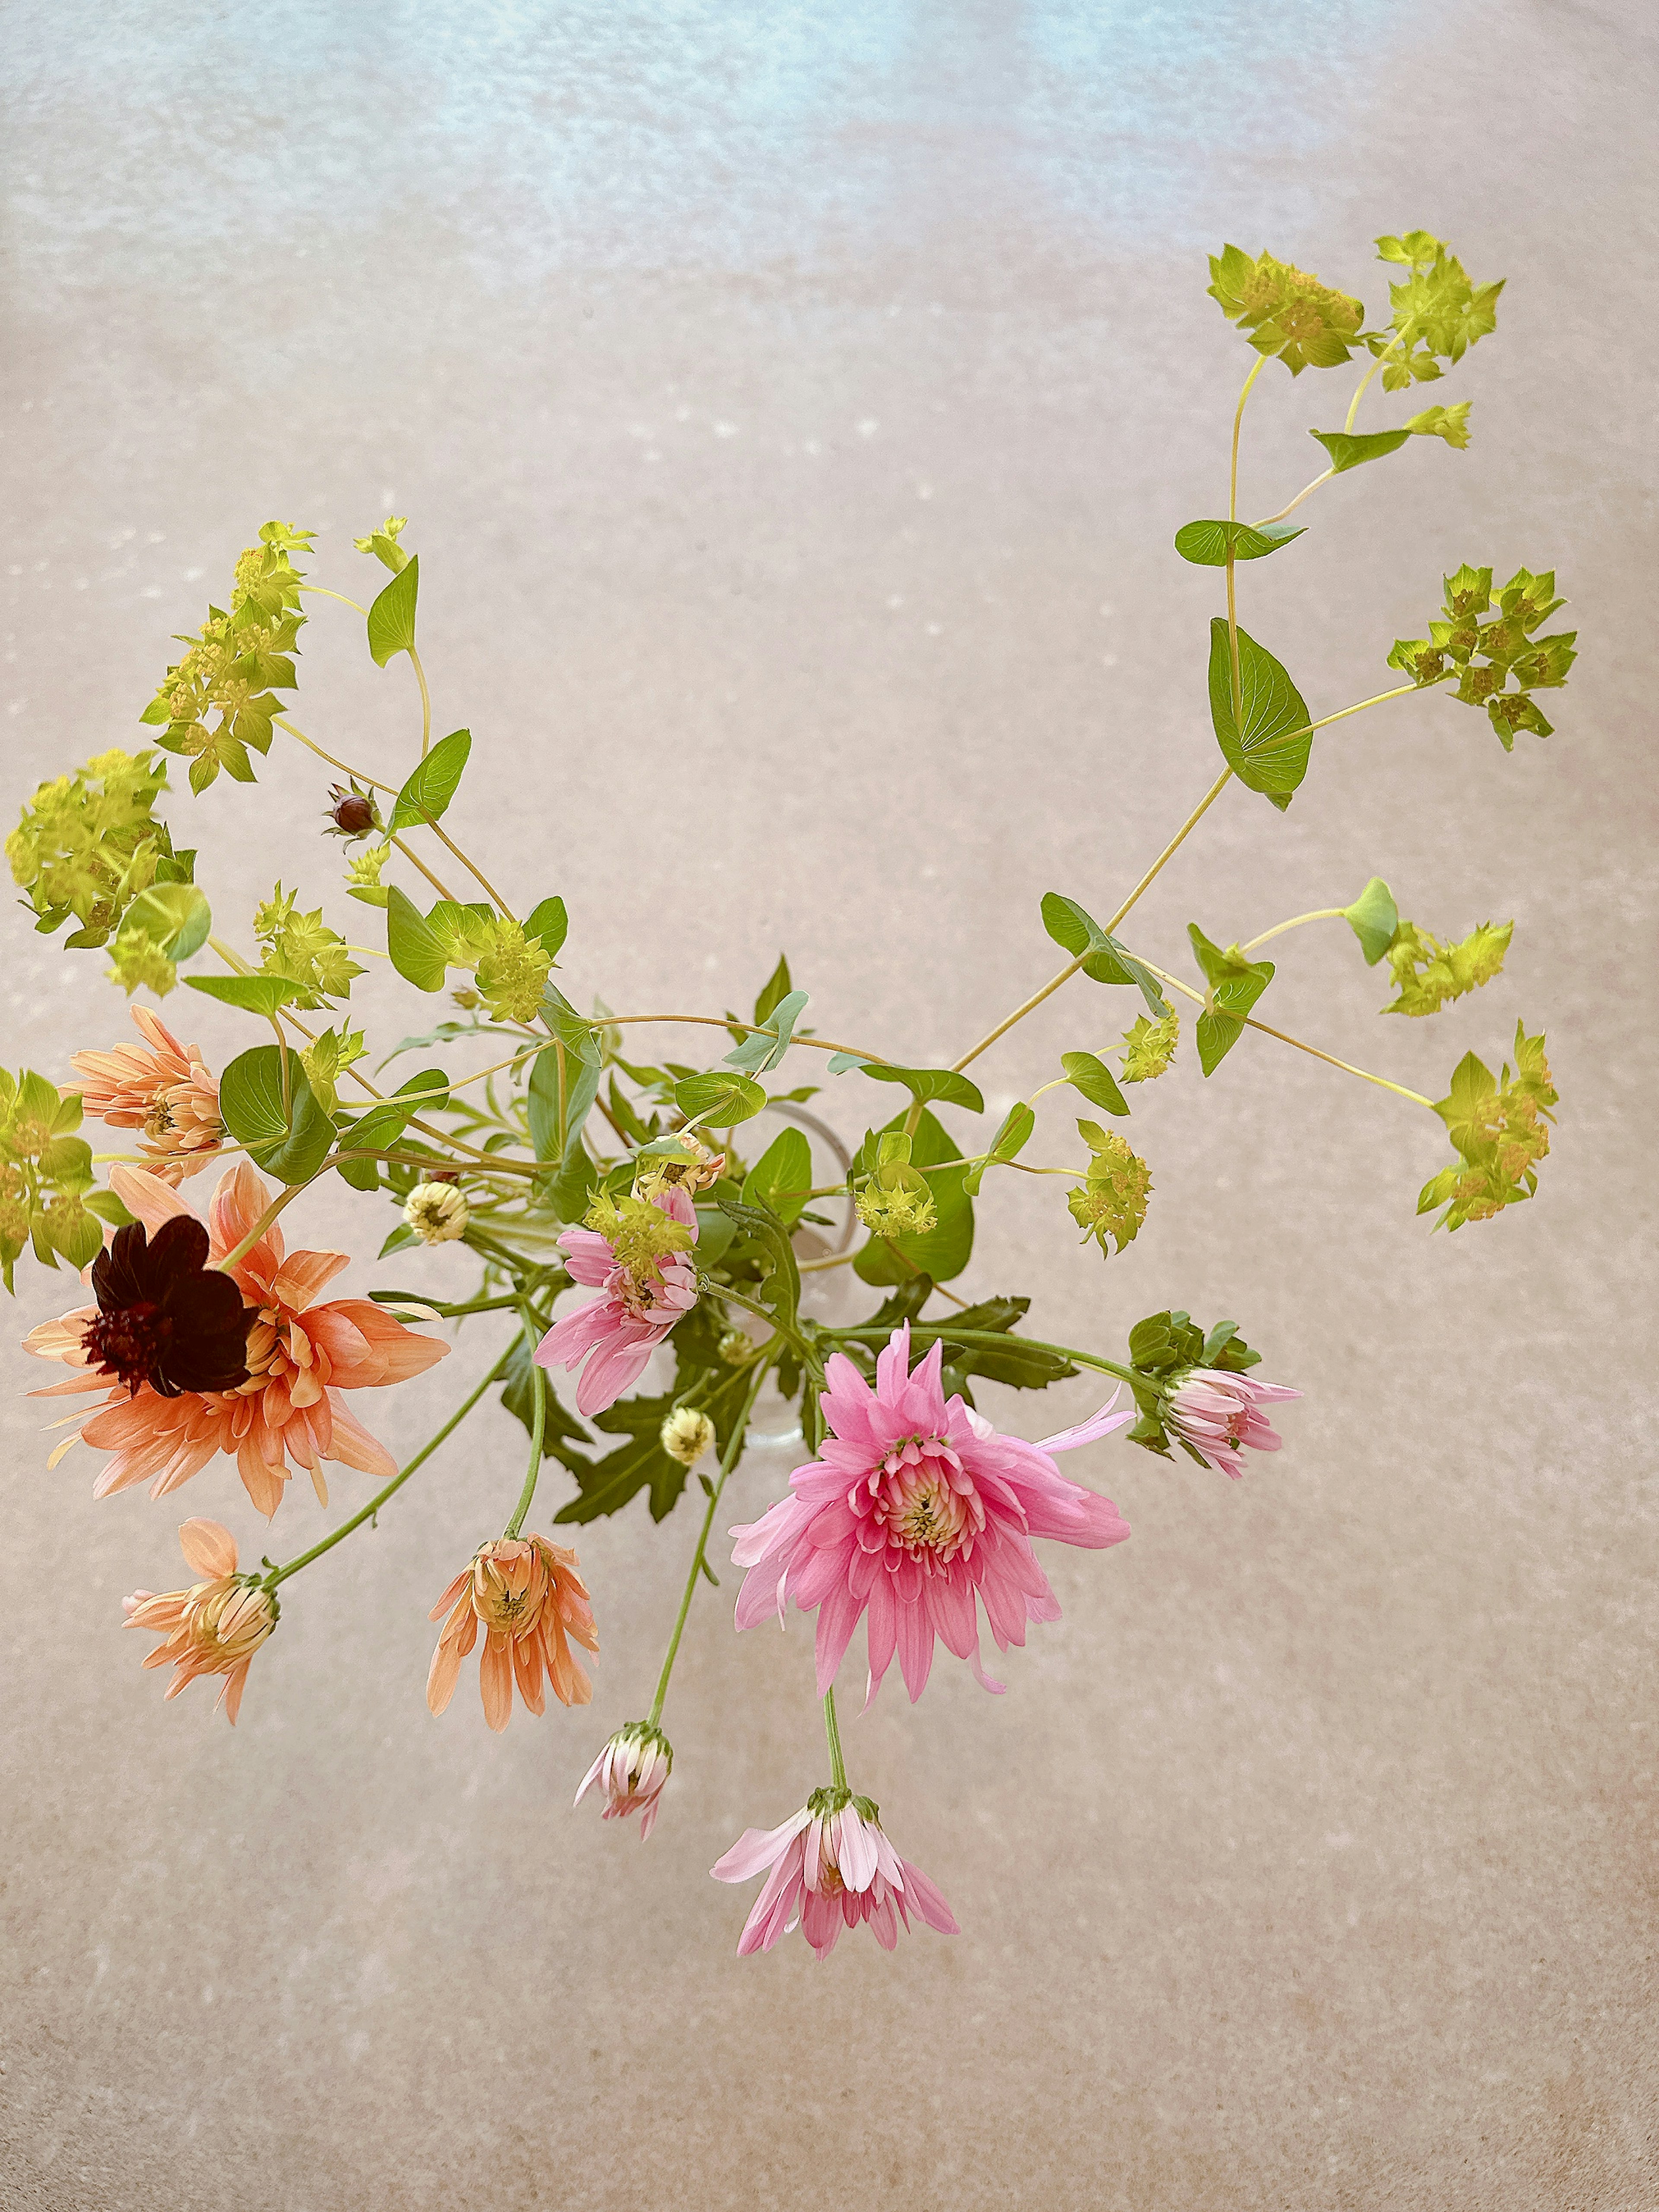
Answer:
top-left (427, 1535), bottom-right (600, 1732)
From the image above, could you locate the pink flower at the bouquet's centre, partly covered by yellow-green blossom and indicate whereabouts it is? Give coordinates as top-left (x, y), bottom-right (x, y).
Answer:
top-left (535, 1185), bottom-right (697, 1414)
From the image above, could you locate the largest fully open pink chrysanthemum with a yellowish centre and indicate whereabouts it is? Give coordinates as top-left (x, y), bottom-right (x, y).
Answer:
top-left (730, 1323), bottom-right (1135, 1701)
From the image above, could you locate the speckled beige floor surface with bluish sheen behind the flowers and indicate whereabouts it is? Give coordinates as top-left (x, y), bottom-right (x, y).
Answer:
top-left (0, 0), bottom-right (1659, 2212)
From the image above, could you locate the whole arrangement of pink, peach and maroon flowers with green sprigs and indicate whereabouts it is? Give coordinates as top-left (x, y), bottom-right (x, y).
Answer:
top-left (0, 230), bottom-right (1575, 1958)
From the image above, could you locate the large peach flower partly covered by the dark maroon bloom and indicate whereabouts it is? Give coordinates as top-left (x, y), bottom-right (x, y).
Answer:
top-left (24, 1161), bottom-right (449, 1517)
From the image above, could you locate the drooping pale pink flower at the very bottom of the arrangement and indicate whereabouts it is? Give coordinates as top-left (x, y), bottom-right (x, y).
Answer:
top-left (708, 1789), bottom-right (962, 1960)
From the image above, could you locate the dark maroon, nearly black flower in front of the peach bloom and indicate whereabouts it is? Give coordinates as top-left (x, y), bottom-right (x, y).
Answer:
top-left (82, 1214), bottom-right (250, 1398)
